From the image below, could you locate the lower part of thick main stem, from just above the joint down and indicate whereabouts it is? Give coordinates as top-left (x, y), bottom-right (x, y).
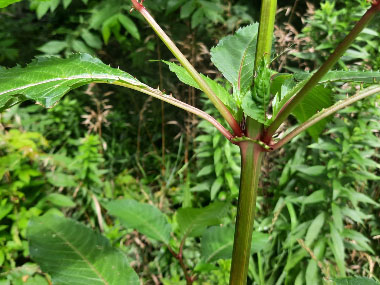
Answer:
top-left (230, 118), bottom-right (264, 285)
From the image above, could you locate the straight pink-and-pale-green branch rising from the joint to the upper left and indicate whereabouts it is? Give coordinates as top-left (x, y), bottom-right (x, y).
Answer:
top-left (131, 0), bottom-right (243, 136)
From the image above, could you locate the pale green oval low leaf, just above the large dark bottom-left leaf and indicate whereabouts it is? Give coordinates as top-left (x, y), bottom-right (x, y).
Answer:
top-left (106, 199), bottom-right (172, 244)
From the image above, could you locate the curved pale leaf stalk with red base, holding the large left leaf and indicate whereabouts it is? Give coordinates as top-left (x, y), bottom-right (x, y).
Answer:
top-left (113, 81), bottom-right (234, 141)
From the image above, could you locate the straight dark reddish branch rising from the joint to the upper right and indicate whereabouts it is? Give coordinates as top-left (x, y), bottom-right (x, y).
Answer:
top-left (264, 3), bottom-right (380, 143)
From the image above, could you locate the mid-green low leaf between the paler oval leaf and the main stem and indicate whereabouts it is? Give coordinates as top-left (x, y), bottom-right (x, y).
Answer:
top-left (177, 202), bottom-right (229, 237)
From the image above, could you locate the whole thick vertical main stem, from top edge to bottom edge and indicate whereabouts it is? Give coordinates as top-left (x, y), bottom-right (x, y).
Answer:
top-left (230, 0), bottom-right (277, 285)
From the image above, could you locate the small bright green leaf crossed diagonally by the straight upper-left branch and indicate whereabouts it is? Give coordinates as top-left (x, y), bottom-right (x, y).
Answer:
top-left (163, 60), bottom-right (237, 114)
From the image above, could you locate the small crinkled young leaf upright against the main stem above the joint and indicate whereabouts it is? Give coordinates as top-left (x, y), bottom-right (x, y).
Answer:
top-left (242, 57), bottom-right (271, 125)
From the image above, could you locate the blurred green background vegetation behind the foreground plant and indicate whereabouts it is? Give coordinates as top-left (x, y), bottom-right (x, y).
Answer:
top-left (0, 0), bottom-right (380, 285)
